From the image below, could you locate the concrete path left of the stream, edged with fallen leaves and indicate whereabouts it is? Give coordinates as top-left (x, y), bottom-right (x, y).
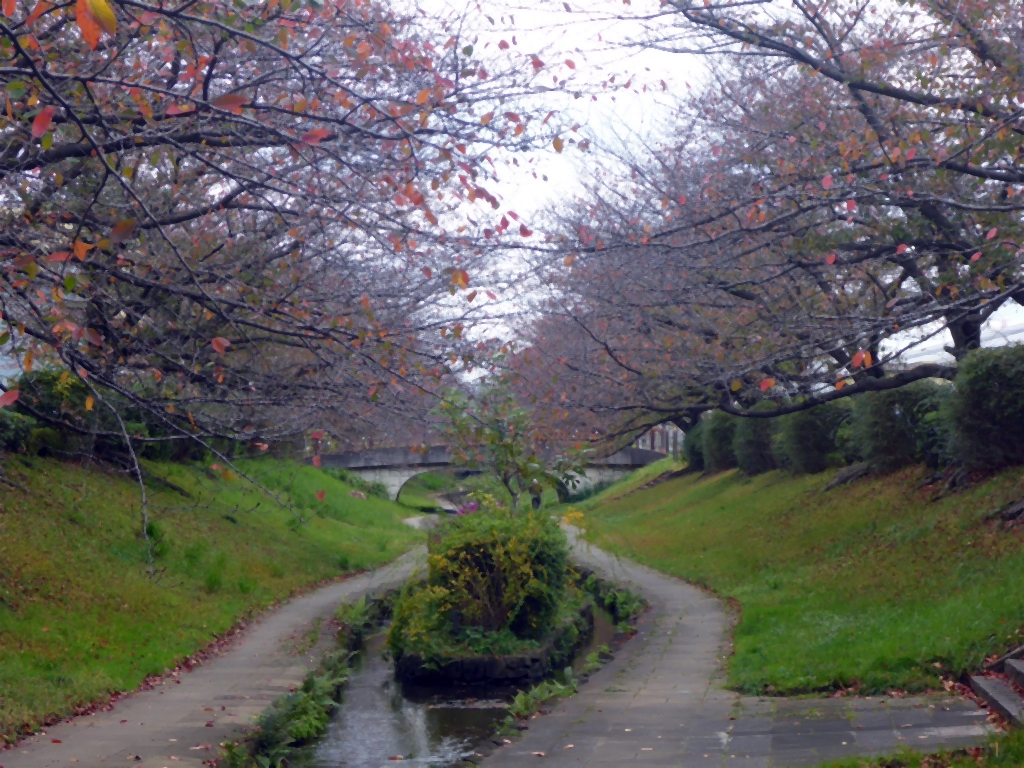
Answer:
top-left (0, 547), bottom-right (425, 768)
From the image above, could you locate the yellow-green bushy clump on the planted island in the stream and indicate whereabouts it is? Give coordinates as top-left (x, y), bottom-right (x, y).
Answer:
top-left (388, 501), bottom-right (568, 658)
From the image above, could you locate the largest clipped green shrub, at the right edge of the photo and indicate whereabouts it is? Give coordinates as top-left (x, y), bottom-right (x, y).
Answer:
top-left (945, 345), bottom-right (1024, 469)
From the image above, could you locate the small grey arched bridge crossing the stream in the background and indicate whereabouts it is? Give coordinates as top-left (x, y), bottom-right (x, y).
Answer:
top-left (321, 445), bottom-right (665, 500)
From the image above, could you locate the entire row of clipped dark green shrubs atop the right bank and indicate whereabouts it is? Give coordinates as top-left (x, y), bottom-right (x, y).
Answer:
top-left (683, 345), bottom-right (1024, 475)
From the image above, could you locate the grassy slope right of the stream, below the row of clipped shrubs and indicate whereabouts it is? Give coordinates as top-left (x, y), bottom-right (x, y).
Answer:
top-left (586, 468), bottom-right (1024, 693)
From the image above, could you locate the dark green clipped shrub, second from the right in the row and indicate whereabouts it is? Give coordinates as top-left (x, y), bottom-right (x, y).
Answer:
top-left (850, 381), bottom-right (950, 472)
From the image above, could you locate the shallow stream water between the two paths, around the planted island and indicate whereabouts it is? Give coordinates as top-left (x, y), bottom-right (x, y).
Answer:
top-left (297, 611), bottom-right (614, 768)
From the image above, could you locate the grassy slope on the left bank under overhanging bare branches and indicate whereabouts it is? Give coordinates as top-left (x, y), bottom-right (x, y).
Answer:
top-left (0, 458), bottom-right (421, 738)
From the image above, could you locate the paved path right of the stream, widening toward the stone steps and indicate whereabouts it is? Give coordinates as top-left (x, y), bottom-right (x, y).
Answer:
top-left (481, 542), bottom-right (989, 768)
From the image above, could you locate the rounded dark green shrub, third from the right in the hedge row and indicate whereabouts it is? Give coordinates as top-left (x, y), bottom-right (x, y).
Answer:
top-left (772, 402), bottom-right (850, 474)
